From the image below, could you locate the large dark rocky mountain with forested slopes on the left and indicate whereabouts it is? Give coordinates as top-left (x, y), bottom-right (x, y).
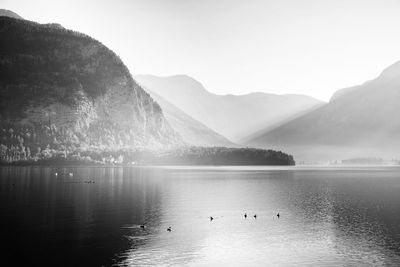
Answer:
top-left (0, 16), bottom-right (182, 163)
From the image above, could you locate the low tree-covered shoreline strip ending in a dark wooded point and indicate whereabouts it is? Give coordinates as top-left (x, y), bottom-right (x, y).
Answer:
top-left (0, 142), bottom-right (295, 166)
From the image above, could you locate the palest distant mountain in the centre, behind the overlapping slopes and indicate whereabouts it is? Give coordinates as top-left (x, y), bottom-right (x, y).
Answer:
top-left (134, 75), bottom-right (321, 142)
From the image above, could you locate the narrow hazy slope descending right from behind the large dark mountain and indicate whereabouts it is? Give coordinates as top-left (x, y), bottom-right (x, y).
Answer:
top-left (144, 87), bottom-right (237, 147)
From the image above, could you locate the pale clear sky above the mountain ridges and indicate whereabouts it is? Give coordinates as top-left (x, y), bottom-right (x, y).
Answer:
top-left (0, 0), bottom-right (400, 100)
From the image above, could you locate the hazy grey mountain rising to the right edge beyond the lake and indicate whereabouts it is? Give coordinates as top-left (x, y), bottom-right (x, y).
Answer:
top-left (248, 62), bottom-right (400, 160)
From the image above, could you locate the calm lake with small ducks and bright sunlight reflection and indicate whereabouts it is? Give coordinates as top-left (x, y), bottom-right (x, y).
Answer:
top-left (0, 167), bottom-right (400, 266)
